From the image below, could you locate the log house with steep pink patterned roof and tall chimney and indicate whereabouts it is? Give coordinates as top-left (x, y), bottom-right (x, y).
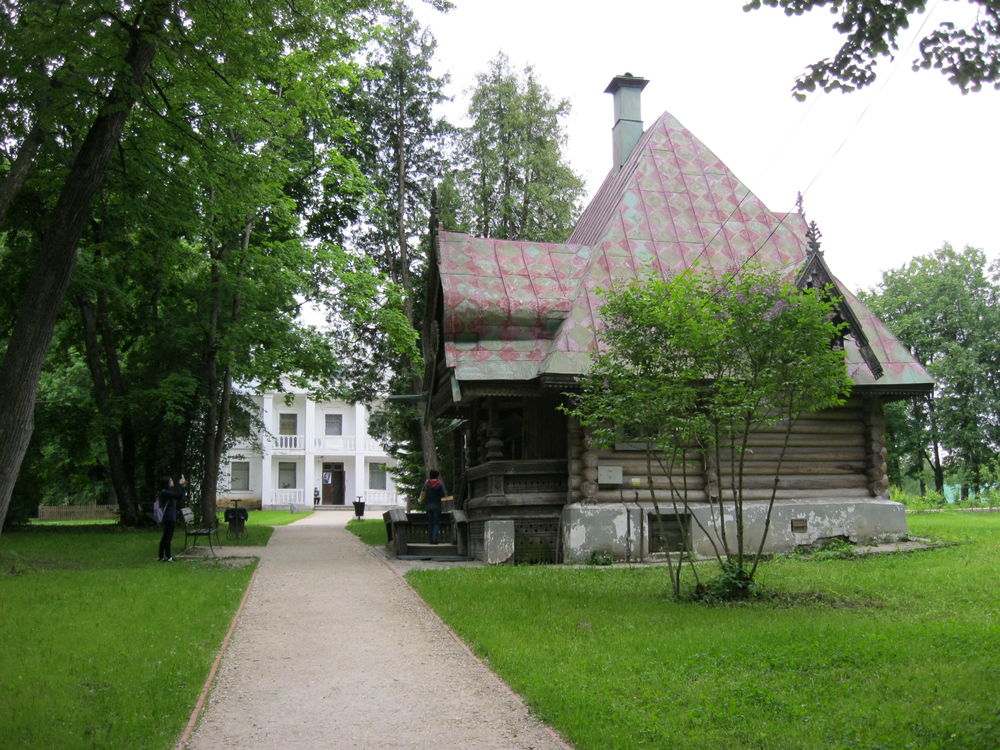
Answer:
top-left (425, 74), bottom-right (932, 561)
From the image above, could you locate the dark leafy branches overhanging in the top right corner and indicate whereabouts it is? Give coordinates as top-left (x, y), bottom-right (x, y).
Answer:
top-left (743, 0), bottom-right (1000, 99)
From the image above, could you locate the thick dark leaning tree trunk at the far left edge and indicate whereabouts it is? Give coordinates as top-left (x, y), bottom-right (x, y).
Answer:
top-left (0, 2), bottom-right (169, 528)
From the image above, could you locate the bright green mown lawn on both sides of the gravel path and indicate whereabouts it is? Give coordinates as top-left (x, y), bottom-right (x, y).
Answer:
top-left (0, 511), bottom-right (1000, 750)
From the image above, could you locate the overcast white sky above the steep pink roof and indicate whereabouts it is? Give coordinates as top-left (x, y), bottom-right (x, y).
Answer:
top-left (409, 0), bottom-right (1000, 291)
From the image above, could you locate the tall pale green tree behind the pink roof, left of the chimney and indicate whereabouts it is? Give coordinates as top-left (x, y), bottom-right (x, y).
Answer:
top-left (440, 53), bottom-right (583, 242)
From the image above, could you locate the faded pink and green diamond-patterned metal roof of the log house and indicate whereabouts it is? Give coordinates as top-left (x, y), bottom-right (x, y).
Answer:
top-left (438, 113), bottom-right (930, 394)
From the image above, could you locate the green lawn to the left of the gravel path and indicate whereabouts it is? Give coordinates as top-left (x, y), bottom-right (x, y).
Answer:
top-left (0, 514), bottom-right (258, 750)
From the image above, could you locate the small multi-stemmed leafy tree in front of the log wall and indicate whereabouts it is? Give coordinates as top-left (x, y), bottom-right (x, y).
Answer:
top-left (566, 269), bottom-right (851, 597)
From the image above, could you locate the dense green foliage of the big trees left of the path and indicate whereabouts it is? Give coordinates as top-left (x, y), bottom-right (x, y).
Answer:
top-left (0, 0), bottom-right (415, 523)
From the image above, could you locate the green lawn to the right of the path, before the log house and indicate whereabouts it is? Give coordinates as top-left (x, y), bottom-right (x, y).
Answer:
top-left (408, 513), bottom-right (1000, 750)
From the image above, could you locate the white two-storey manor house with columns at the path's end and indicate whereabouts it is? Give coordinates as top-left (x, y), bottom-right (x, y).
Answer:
top-left (218, 389), bottom-right (406, 510)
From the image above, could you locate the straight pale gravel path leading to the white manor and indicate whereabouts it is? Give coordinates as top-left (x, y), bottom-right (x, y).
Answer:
top-left (178, 512), bottom-right (568, 750)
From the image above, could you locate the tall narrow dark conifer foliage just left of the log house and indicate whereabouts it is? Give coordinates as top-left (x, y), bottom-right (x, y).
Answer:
top-left (352, 2), bottom-right (450, 482)
